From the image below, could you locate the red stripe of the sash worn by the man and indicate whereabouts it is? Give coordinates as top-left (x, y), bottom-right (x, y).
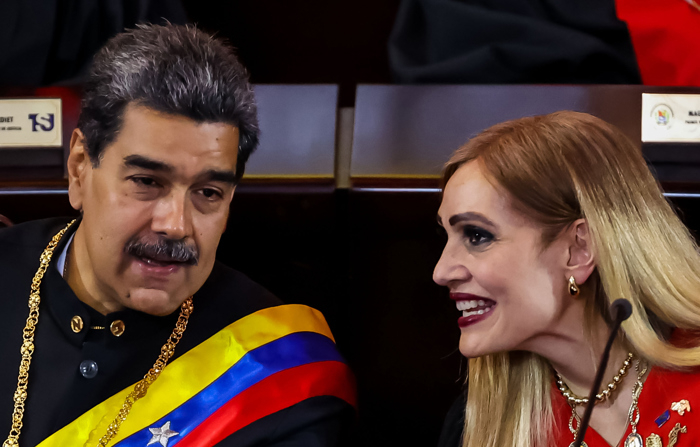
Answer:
top-left (177, 361), bottom-right (356, 447)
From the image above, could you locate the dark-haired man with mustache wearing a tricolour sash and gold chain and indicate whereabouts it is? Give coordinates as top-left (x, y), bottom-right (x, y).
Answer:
top-left (0, 25), bottom-right (354, 447)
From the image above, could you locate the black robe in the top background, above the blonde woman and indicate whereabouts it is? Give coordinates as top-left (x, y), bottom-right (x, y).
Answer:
top-left (389, 0), bottom-right (641, 84)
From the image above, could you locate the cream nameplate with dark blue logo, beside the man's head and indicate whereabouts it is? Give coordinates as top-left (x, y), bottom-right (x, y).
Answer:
top-left (0, 98), bottom-right (63, 149)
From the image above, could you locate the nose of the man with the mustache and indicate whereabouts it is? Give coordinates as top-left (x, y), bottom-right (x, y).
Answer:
top-left (151, 191), bottom-right (192, 240)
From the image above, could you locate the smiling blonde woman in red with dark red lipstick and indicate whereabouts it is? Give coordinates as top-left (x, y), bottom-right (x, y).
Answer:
top-left (434, 112), bottom-right (700, 447)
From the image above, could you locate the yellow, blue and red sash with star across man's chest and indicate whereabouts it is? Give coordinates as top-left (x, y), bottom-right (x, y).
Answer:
top-left (39, 305), bottom-right (356, 447)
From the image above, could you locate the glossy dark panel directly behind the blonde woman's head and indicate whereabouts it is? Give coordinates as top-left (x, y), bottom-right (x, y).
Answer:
top-left (351, 85), bottom-right (700, 182)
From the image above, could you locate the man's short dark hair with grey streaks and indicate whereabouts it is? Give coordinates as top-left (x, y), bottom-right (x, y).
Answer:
top-left (78, 25), bottom-right (260, 180)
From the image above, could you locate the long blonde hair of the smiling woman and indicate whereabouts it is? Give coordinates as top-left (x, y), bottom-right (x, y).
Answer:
top-left (443, 111), bottom-right (700, 447)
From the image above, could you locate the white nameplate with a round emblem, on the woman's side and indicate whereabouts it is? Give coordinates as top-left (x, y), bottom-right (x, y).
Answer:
top-left (642, 93), bottom-right (700, 143)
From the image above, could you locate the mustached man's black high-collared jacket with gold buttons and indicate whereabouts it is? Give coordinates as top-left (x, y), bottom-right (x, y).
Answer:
top-left (0, 219), bottom-right (355, 447)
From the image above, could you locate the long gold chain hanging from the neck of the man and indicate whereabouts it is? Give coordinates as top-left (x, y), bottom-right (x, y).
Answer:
top-left (2, 220), bottom-right (194, 447)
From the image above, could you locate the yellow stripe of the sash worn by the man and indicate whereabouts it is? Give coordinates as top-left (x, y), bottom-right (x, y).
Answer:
top-left (37, 304), bottom-right (335, 447)
